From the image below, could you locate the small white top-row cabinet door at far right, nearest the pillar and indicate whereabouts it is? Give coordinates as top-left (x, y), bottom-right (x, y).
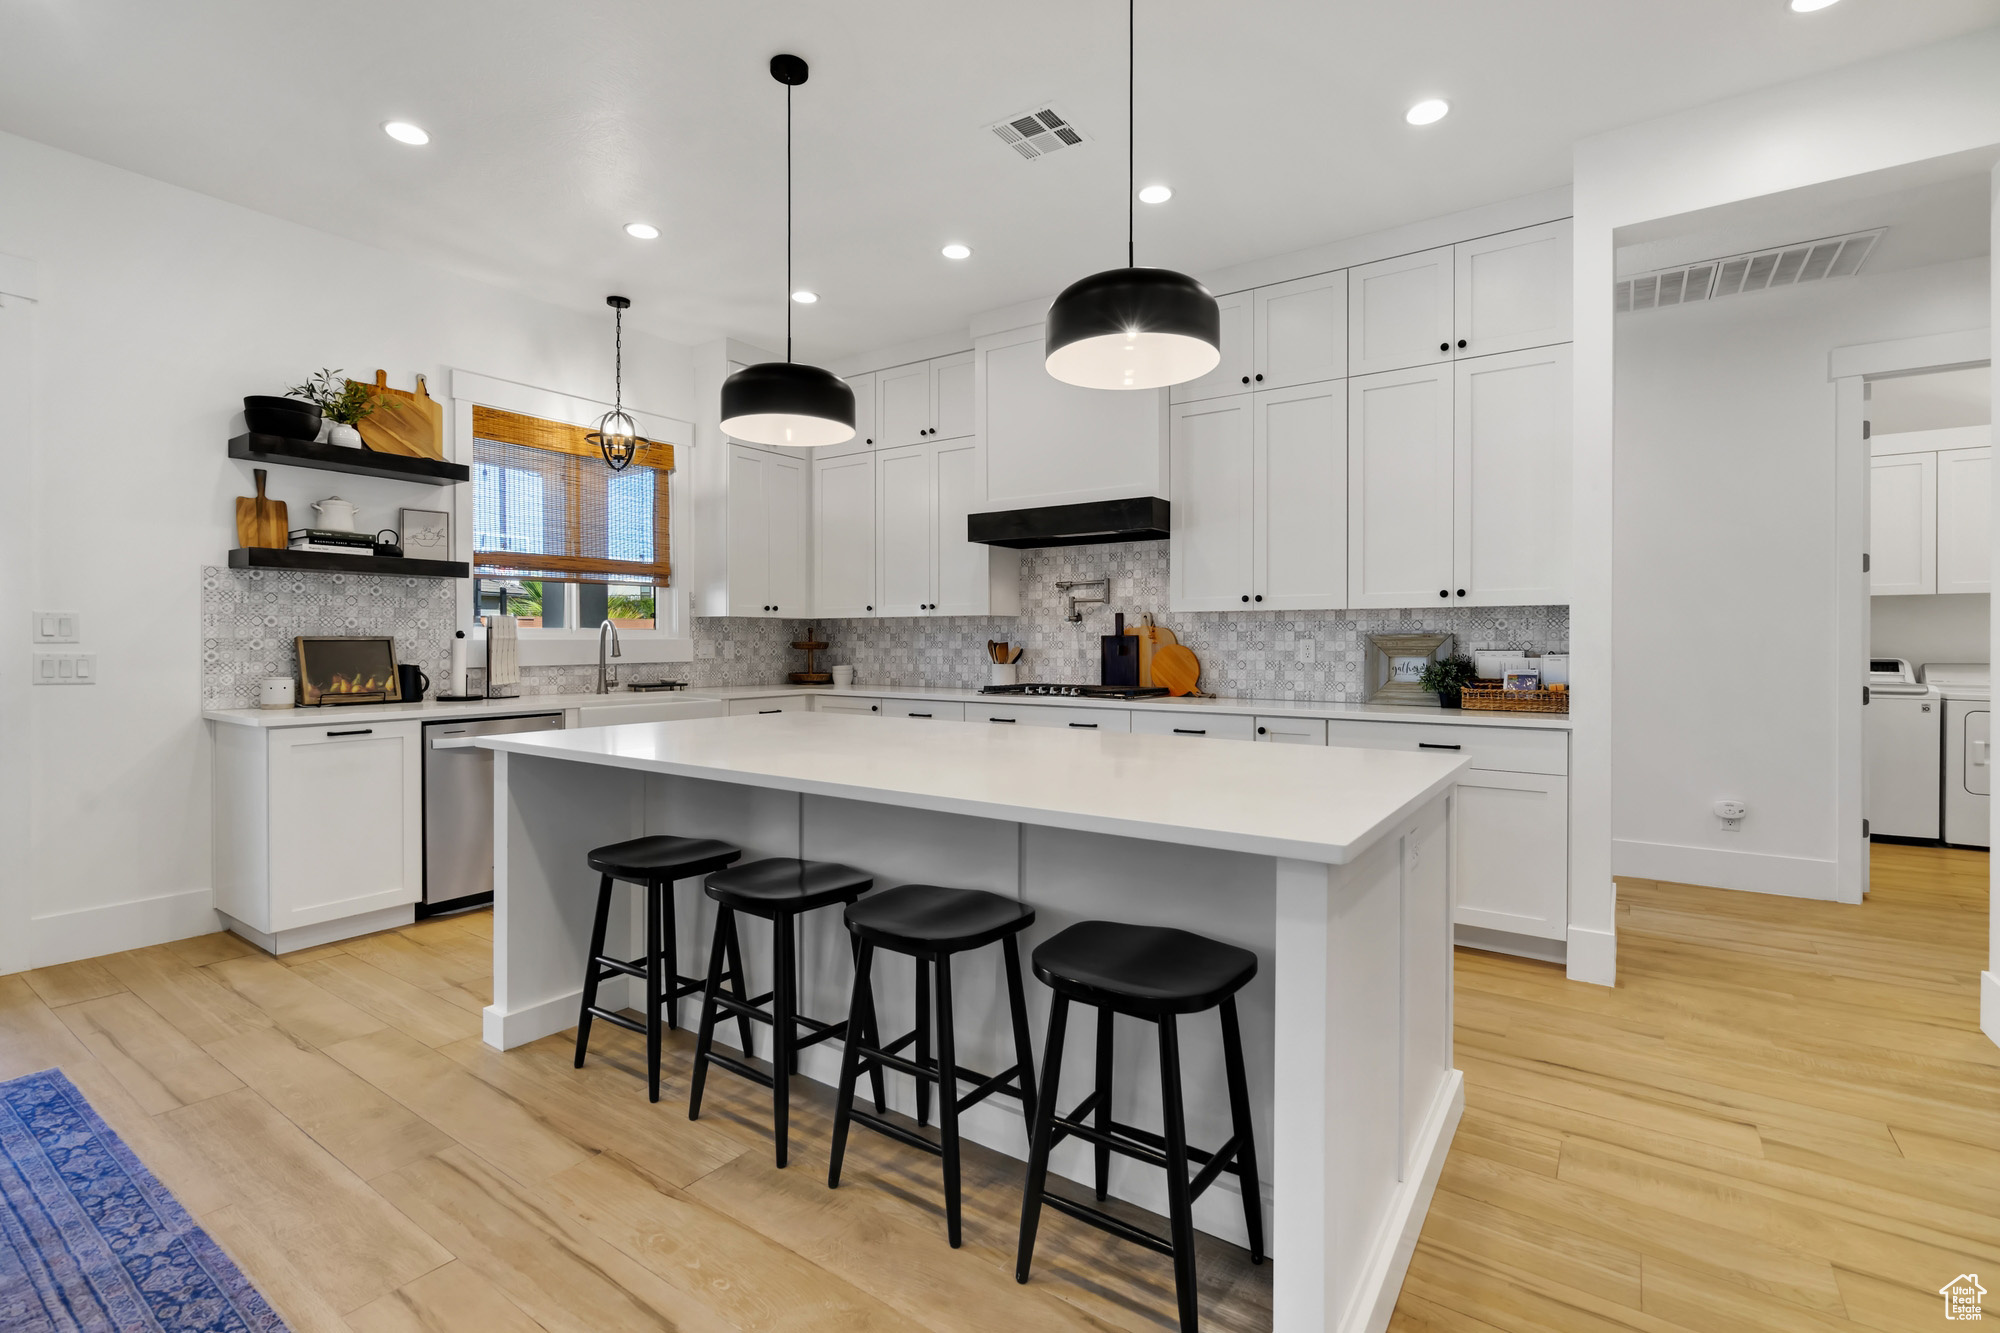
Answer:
top-left (1452, 218), bottom-right (1570, 356)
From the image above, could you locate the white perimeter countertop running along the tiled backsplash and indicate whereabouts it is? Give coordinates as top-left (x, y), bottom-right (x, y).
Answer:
top-left (202, 685), bottom-right (1570, 731)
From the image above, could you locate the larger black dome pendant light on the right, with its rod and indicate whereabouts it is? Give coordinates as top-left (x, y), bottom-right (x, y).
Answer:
top-left (1044, 0), bottom-right (1222, 388)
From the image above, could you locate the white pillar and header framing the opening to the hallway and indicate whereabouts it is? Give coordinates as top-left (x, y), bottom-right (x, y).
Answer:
top-left (1570, 15), bottom-right (2000, 980)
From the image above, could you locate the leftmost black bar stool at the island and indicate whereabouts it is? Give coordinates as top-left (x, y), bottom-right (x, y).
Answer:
top-left (576, 833), bottom-right (750, 1101)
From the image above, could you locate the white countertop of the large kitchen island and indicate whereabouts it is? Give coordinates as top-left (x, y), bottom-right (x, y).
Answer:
top-left (474, 713), bottom-right (1468, 865)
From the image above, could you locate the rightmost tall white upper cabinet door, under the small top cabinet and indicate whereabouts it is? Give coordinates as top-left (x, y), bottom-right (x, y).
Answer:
top-left (1452, 342), bottom-right (1570, 606)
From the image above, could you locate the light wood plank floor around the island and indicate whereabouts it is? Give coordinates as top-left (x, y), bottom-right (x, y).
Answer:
top-left (0, 847), bottom-right (2000, 1333)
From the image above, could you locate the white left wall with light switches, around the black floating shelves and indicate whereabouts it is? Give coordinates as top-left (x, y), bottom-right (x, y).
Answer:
top-left (0, 127), bottom-right (692, 971)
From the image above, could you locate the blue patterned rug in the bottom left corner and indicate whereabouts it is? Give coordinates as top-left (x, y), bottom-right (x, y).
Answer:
top-left (0, 1069), bottom-right (286, 1333)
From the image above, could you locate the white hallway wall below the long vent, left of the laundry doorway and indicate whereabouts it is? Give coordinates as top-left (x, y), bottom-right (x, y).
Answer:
top-left (1612, 260), bottom-right (1988, 899)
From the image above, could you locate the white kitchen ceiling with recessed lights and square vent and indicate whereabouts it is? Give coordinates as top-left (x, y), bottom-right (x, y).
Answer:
top-left (0, 0), bottom-right (2000, 358)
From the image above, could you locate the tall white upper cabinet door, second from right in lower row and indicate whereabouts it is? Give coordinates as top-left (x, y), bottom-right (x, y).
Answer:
top-left (1348, 364), bottom-right (1454, 606)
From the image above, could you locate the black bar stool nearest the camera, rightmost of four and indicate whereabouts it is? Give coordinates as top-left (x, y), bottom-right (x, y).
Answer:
top-left (1014, 921), bottom-right (1264, 1333)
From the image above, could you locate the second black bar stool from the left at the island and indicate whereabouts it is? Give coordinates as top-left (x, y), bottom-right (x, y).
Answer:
top-left (688, 857), bottom-right (882, 1167)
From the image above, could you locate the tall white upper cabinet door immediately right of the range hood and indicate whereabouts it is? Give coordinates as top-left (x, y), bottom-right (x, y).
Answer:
top-left (1168, 394), bottom-right (1254, 610)
